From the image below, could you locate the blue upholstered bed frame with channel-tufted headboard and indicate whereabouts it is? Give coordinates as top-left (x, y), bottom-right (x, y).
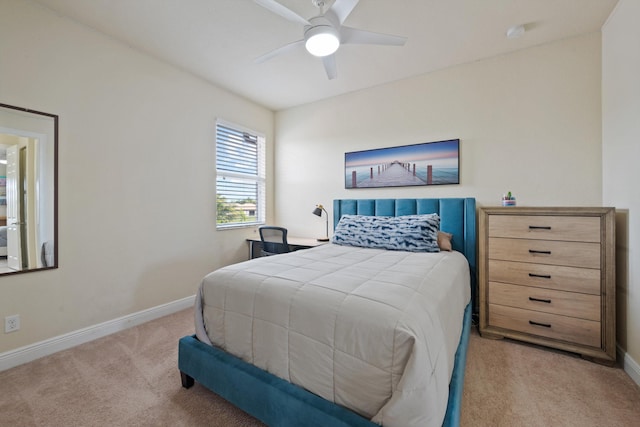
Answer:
top-left (178, 198), bottom-right (477, 427)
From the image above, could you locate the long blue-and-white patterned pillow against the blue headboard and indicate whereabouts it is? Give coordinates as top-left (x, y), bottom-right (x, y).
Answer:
top-left (332, 214), bottom-right (440, 252)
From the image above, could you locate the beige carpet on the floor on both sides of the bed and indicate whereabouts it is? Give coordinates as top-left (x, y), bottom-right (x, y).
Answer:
top-left (0, 310), bottom-right (640, 427)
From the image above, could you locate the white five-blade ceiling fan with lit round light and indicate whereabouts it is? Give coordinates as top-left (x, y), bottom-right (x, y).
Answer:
top-left (254, 0), bottom-right (407, 80)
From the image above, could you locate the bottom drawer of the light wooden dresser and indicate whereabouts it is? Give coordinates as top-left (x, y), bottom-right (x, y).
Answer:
top-left (489, 304), bottom-right (601, 347)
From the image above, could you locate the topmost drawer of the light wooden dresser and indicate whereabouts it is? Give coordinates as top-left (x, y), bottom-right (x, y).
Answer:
top-left (489, 215), bottom-right (600, 243)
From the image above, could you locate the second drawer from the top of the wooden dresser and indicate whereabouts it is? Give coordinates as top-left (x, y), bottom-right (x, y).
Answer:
top-left (489, 237), bottom-right (600, 269)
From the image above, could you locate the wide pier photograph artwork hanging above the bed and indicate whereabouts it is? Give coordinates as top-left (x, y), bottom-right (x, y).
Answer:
top-left (344, 139), bottom-right (460, 188)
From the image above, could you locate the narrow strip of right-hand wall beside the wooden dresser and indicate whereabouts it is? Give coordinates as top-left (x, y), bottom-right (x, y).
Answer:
top-left (602, 0), bottom-right (640, 382)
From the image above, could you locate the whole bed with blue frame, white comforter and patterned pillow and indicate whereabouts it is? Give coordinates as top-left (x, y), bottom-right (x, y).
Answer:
top-left (178, 198), bottom-right (476, 427)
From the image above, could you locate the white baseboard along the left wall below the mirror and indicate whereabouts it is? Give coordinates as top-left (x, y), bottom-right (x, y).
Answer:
top-left (0, 295), bottom-right (195, 372)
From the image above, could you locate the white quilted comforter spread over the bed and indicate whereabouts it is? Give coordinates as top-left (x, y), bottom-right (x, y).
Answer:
top-left (196, 244), bottom-right (470, 427)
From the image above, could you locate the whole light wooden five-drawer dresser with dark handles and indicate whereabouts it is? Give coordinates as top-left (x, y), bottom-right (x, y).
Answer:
top-left (478, 207), bottom-right (616, 364)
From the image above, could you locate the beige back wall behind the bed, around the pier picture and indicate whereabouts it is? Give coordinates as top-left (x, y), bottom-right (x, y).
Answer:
top-left (275, 33), bottom-right (602, 236)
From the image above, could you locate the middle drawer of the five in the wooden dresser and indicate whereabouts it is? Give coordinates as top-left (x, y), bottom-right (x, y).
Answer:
top-left (489, 259), bottom-right (601, 295)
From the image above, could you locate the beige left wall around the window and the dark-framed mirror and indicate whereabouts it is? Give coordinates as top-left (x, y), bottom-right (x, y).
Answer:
top-left (0, 0), bottom-right (274, 353)
